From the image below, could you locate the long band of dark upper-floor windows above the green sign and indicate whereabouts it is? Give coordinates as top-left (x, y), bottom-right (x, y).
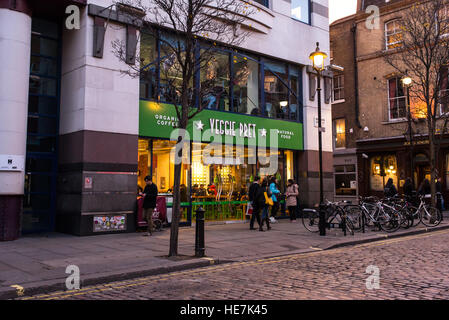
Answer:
top-left (140, 27), bottom-right (302, 121)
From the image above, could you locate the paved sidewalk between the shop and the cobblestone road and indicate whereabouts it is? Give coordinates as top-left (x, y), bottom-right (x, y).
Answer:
top-left (0, 214), bottom-right (449, 299)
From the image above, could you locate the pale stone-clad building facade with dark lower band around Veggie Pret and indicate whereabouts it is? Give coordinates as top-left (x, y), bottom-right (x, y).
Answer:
top-left (0, 0), bottom-right (333, 240)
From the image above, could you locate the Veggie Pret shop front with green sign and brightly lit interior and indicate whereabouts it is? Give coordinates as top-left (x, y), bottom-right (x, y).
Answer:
top-left (138, 100), bottom-right (303, 226)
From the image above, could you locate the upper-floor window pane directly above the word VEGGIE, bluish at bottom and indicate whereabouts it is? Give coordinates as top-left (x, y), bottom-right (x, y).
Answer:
top-left (200, 51), bottom-right (230, 111)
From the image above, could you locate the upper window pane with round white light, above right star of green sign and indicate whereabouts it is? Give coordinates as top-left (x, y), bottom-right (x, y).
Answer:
top-left (264, 61), bottom-right (290, 119)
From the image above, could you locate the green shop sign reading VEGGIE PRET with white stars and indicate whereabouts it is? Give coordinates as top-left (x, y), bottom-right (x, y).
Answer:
top-left (139, 100), bottom-right (304, 150)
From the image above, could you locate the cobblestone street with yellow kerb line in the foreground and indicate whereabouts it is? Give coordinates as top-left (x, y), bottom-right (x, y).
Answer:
top-left (24, 230), bottom-right (449, 300)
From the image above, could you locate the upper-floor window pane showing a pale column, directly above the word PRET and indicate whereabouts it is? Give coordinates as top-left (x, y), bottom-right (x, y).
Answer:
top-left (233, 55), bottom-right (259, 115)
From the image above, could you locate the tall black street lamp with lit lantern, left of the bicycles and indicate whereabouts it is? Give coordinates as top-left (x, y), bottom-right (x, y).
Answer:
top-left (309, 42), bottom-right (327, 236)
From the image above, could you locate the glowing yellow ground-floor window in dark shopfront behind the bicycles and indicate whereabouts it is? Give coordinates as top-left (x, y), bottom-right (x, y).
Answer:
top-left (370, 155), bottom-right (398, 191)
